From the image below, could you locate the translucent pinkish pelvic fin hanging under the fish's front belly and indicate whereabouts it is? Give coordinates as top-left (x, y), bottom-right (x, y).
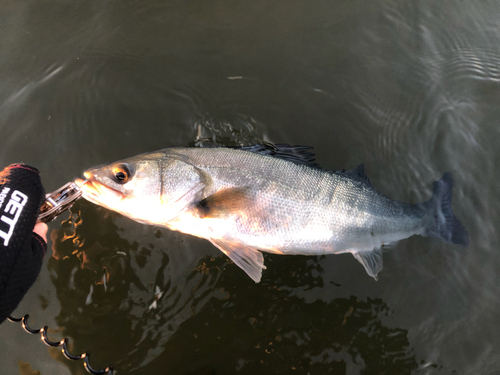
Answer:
top-left (209, 238), bottom-right (266, 283)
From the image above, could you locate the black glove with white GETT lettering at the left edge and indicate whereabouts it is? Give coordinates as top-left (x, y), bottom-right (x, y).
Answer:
top-left (0, 164), bottom-right (47, 323)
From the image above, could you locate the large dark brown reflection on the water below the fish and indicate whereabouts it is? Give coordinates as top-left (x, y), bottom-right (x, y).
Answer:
top-left (49, 201), bottom-right (426, 374)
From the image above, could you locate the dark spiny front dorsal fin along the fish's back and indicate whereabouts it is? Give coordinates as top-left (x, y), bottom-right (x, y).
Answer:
top-left (232, 143), bottom-right (318, 167)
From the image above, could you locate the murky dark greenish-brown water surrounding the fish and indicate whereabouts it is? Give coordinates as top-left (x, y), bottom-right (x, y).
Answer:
top-left (0, 0), bottom-right (500, 374)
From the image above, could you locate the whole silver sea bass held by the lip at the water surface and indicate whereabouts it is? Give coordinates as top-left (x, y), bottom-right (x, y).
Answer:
top-left (82, 145), bottom-right (469, 282)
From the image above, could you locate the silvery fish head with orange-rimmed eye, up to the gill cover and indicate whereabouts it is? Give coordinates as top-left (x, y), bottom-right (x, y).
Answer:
top-left (82, 152), bottom-right (205, 225)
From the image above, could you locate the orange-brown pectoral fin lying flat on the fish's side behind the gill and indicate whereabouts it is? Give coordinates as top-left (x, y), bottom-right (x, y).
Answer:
top-left (196, 188), bottom-right (251, 218)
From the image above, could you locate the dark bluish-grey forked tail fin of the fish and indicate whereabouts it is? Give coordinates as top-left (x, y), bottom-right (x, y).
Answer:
top-left (423, 172), bottom-right (469, 246)
